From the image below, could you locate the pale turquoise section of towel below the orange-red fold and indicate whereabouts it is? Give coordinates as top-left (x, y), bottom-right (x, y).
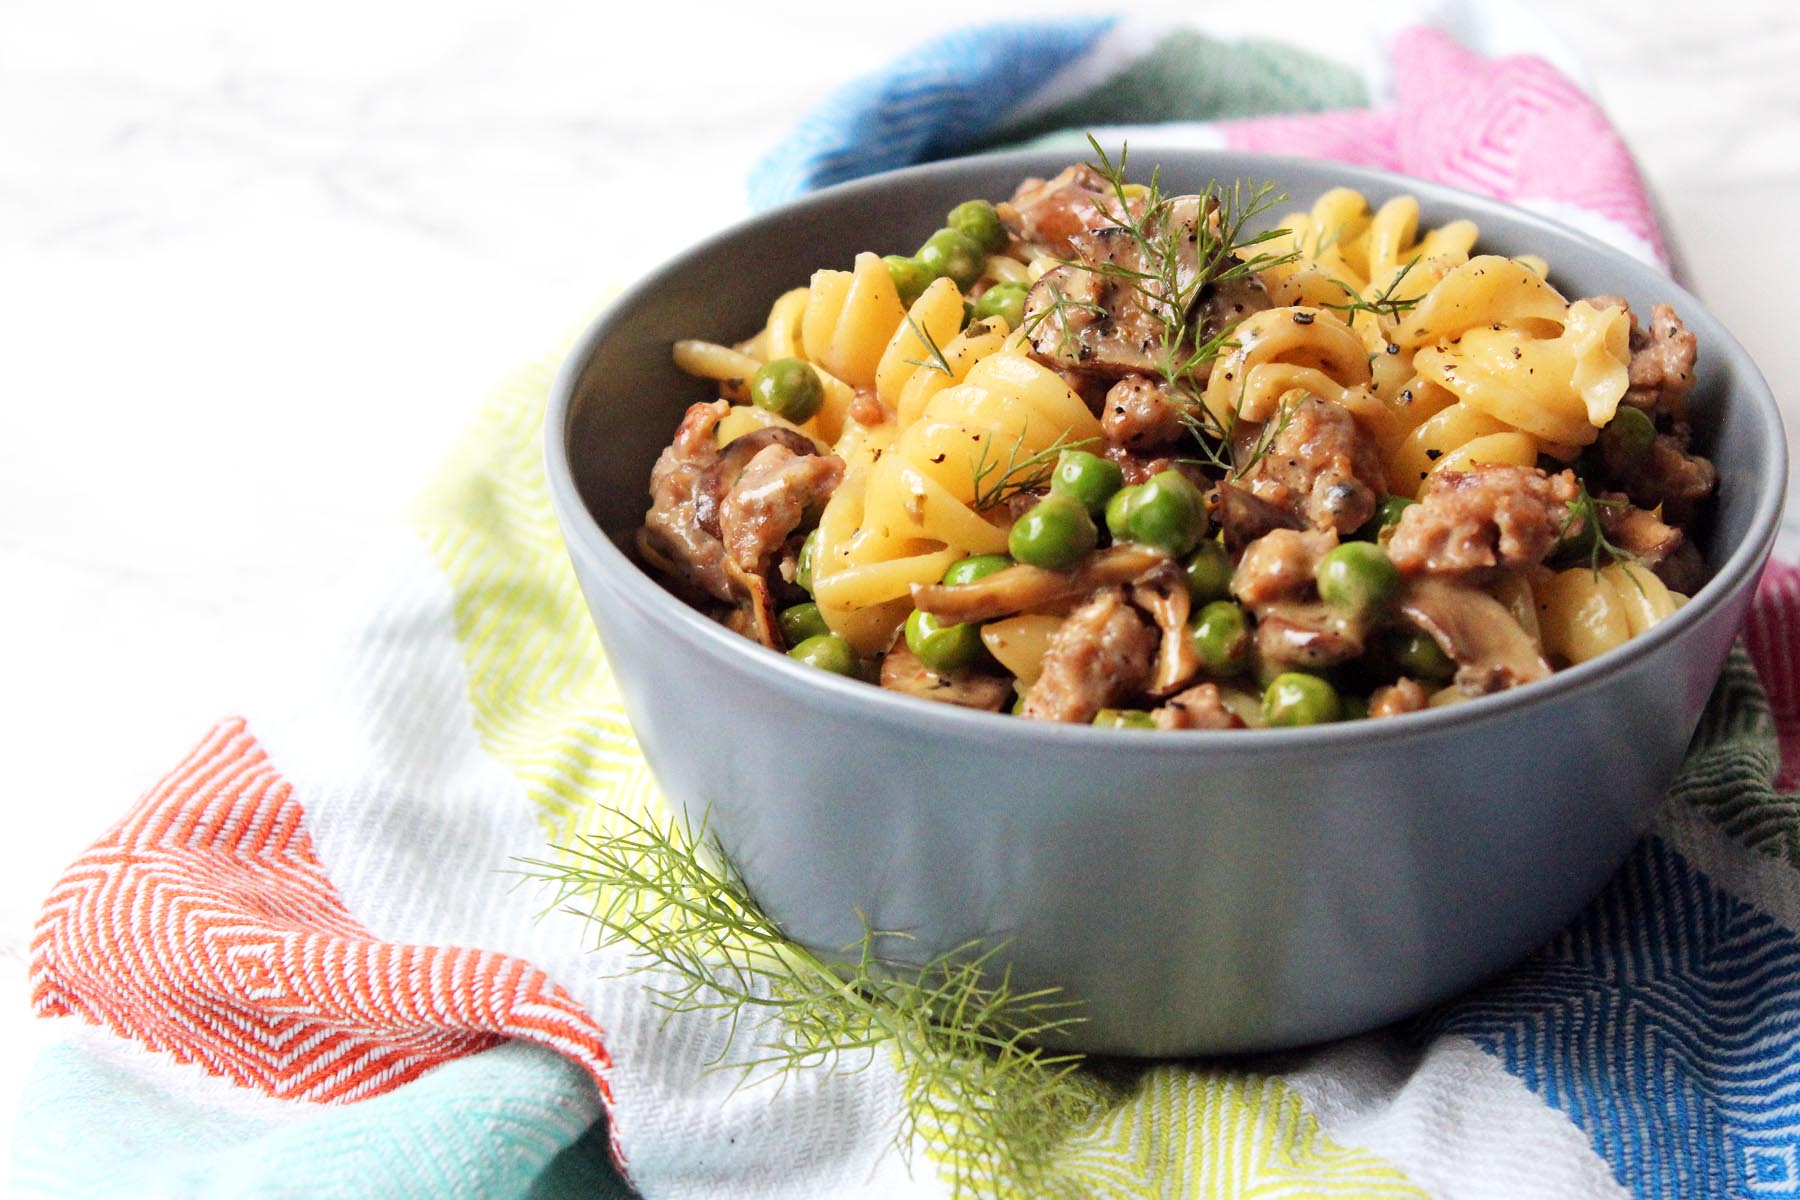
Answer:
top-left (7, 1042), bottom-right (634, 1200)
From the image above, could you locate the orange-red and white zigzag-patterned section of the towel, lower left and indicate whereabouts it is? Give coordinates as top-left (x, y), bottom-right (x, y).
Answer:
top-left (31, 720), bottom-right (612, 1114)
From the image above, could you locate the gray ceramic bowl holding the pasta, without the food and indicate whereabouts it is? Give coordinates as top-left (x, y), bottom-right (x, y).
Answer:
top-left (545, 149), bottom-right (1786, 1054)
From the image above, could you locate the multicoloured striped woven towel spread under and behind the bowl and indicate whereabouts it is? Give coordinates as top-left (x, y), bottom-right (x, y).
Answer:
top-left (13, 11), bottom-right (1800, 1200)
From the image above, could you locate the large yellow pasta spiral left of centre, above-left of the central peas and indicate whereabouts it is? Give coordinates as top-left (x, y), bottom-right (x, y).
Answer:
top-left (814, 354), bottom-right (1100, 653)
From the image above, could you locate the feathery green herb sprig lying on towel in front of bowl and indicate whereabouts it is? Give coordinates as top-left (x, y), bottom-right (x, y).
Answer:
top-left (526, 811), bottom-right (1093, 1196)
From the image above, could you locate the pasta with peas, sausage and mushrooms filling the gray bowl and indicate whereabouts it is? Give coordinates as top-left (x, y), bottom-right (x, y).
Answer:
top-left (637, 146), bottom-right (1715, 729)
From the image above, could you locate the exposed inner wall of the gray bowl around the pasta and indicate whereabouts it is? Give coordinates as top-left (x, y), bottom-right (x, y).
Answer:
top-left (547, 148), bottom-right (1786, 738)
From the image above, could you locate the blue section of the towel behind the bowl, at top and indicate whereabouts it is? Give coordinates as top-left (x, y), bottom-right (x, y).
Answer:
top-left (749, 18), bottom-right (1114, 209)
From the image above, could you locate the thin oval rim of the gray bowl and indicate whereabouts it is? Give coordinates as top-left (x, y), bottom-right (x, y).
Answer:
top-left (544, 142), bottom-right (1789, 757)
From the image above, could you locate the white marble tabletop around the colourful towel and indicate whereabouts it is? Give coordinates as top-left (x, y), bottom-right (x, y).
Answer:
top-left (0, 0), bottom-right (1800, 1173)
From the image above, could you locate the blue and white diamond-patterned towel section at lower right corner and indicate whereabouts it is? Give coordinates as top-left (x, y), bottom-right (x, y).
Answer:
top-left (1426, 838), bottom-right (1800, 1200)
